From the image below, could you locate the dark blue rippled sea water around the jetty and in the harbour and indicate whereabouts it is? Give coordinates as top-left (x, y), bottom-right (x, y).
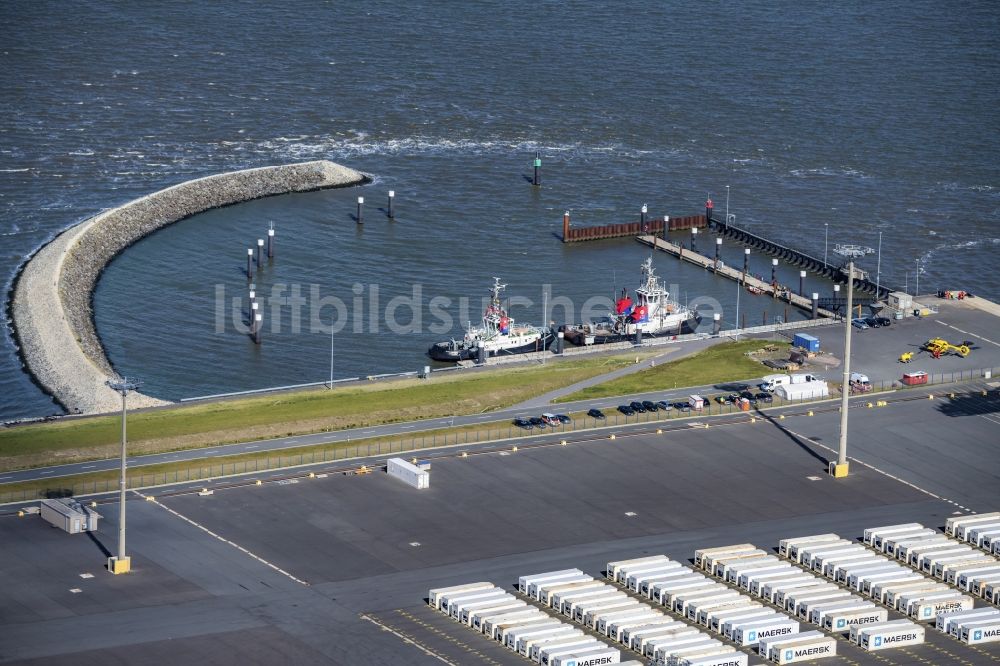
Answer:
top-left (0, 2), bottom-right (1000, 418)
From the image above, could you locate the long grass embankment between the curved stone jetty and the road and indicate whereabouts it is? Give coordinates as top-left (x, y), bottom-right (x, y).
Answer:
top-left (0, 352), bottom-right (655, 470)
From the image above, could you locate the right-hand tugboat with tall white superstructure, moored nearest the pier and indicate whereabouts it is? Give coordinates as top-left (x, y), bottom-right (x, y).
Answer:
top-left (560, 257), bottom-right (701, 346)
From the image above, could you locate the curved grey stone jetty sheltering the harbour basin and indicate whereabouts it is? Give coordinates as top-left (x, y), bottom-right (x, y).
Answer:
top-left (11, 160), bottom-right (369, 414)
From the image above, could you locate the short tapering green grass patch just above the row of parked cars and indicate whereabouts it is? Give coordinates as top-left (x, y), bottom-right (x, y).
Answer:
top-left (556, 340), bottom-right (790, 402)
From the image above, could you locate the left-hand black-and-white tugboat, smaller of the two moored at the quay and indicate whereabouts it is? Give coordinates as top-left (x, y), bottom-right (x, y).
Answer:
top-left (427, 277), bottom-right (555, 362)
